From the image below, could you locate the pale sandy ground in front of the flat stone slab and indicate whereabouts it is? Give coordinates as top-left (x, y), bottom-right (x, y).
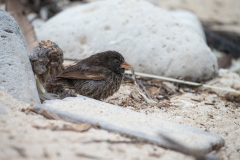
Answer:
top-left (0, 92), bottom-right (195, 160)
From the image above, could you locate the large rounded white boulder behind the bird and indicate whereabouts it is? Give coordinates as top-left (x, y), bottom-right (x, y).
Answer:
top-left (37, 0), bottom-right (218, 80)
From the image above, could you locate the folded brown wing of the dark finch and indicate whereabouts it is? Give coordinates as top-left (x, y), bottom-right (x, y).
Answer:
top-left (57, 62), bottom-right (107, 80)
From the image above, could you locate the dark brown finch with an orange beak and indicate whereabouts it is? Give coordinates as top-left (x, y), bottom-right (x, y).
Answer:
top-left (57, 51), bottom-right (131, 99)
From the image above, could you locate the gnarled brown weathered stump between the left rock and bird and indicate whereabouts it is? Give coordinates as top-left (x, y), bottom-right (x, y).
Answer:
top-left (29, 40), bottom-right (75, 100)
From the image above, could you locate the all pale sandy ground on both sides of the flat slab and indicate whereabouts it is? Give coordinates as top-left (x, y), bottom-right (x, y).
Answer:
top-left (0, 70), bottom-right (240, 160)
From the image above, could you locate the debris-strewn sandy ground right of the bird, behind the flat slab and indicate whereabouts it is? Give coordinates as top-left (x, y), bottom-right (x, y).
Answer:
top-left (104, 71), bottom-right (240, 159)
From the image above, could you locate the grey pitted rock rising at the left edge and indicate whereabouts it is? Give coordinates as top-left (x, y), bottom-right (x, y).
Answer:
top-left (0, 10), bottom-right (40, 103)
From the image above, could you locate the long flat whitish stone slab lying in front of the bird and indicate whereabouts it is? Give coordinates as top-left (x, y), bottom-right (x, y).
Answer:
top-left (33, 96), bottom-right (224, 153)
